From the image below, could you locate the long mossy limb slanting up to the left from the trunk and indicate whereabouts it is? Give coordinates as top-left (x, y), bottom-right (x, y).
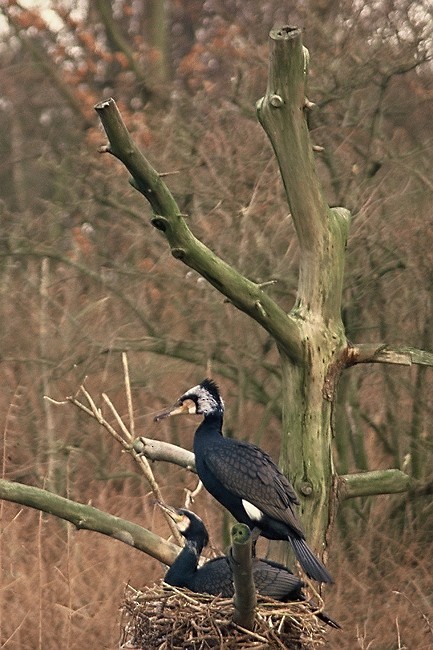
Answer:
top-left (95, 99), bottom-right (303, 362)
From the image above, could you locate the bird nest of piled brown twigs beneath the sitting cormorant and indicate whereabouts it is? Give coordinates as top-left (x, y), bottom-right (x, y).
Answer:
top-left (119, 583), bottom-right (325, 650)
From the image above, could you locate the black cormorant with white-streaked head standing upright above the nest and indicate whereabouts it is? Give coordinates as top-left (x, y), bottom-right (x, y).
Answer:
top-left (155, 379), bottom-right (333, 582)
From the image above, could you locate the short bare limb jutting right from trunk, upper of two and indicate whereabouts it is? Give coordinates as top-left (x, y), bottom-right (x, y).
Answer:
top-left (346, 343), bottom-right (433, 366)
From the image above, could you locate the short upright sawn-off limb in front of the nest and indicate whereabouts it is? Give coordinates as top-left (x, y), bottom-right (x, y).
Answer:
top-left (229, 524), bottom-right (257, 630)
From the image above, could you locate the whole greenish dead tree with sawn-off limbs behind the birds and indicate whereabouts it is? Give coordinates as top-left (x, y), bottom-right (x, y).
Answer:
top-left (95, 26), bottom-right (433, 550)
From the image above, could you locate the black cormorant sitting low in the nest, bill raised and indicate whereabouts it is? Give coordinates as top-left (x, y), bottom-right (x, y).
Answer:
top-left (158, 503), bottom-right (340, 628)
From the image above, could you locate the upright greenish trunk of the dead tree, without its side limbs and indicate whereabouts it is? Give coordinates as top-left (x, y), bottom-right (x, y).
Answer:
top-left (257, 27), bottom-right (349, 549)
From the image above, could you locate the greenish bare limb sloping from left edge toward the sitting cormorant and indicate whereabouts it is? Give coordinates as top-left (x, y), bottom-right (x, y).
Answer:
top-left (0, 479), bottom-right (179, 565)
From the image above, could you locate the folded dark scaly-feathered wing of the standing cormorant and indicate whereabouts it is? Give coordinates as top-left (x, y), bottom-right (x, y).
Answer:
top-left (204, 438), bottom-right (304, 537)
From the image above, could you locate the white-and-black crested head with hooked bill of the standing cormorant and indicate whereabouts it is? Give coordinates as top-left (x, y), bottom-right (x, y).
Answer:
top-left (154, 379), bottom-right (224, 422)
